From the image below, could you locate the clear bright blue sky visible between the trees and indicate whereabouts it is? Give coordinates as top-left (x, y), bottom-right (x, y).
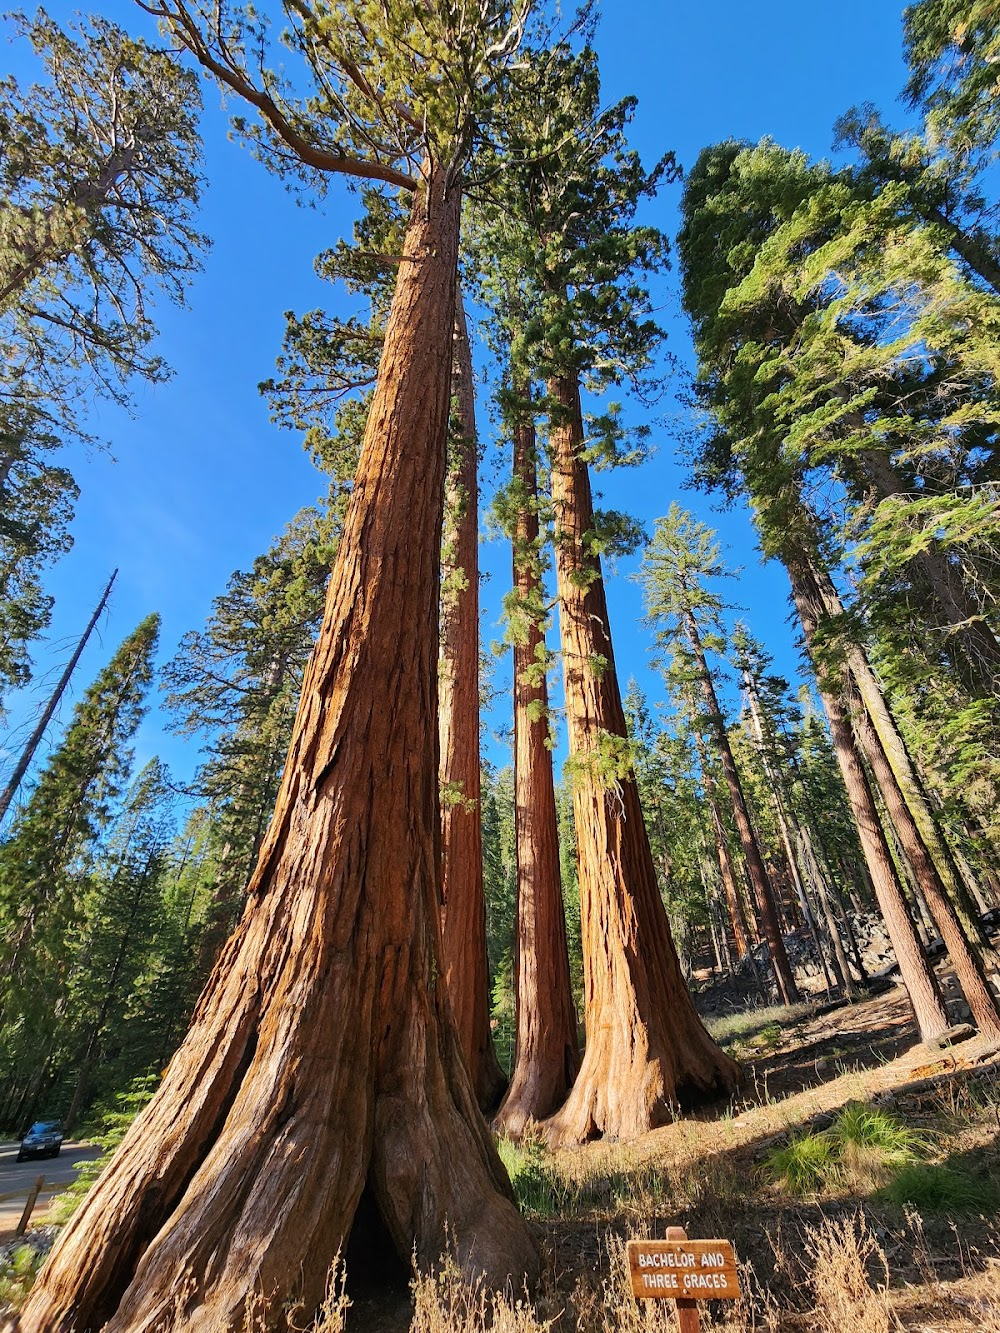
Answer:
top-left (4, 0), bottom-right (904, 799)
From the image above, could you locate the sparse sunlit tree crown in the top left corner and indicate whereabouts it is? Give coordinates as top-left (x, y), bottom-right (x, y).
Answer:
top-left (0, 11), bottom-right (205, 433)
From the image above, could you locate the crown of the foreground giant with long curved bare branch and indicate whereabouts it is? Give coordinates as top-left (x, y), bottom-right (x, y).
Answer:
top-left (147, 0), bottom-right (532, 193)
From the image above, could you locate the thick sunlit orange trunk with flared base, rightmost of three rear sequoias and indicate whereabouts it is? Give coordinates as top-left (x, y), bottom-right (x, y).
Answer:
top-left (536, 379), bottom-right (740, 1142)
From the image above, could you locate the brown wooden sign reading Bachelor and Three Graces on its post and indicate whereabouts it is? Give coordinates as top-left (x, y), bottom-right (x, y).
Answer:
top-left (628, 1226), bottom-right (740, 1333)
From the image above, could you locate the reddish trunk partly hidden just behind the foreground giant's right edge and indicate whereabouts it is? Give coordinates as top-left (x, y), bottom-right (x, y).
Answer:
top-left (437, 297), bottom-right (507, 1110)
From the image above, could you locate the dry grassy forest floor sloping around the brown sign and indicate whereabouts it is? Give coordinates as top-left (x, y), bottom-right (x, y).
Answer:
top-left (347, 970), bottom-right (1000, 1333)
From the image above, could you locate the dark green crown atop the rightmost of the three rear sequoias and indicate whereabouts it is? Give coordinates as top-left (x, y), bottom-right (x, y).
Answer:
top-left (472, 32), bottom-right (673, 410)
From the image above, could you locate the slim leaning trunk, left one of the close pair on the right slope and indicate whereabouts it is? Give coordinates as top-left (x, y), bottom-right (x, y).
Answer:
top-left (787, 560), bottom-right (949, 1041)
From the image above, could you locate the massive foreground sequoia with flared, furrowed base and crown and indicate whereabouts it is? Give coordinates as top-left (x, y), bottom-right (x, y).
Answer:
top-left (20, 0), bottom-right (549, 1333)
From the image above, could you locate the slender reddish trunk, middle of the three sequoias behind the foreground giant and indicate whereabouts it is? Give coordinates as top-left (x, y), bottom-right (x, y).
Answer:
top-left (497, 395), bottom-right (580, 1137)
